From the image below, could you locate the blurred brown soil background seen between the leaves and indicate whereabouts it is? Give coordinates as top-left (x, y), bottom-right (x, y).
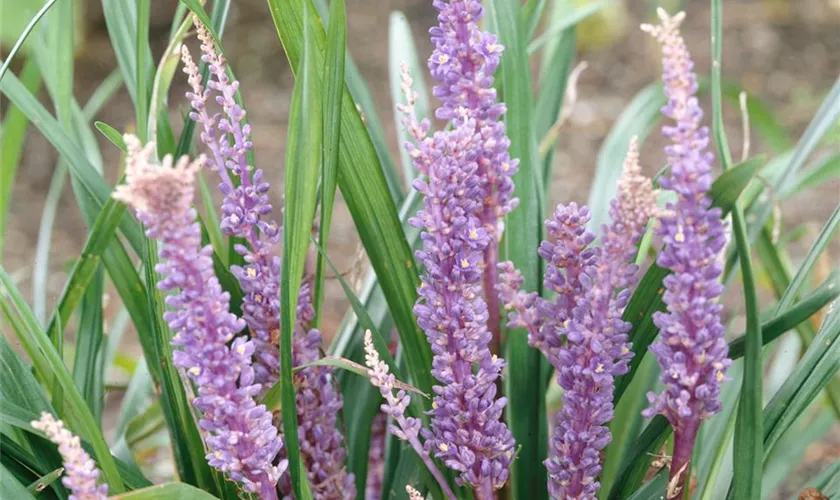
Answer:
top-left (0, 0), bottom-right (840, 492)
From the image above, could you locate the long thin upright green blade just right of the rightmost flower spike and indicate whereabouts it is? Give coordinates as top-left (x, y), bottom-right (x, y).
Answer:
top-left (711, 0), bottom-right (764, 498)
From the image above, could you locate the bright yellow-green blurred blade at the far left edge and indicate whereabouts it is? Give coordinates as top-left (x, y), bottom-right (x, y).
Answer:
top-left (0, 57), bottom-right (41, 258)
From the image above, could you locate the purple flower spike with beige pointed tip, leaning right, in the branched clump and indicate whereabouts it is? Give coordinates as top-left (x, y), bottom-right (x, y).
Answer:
top-left (546, 140), bottom-right (657, 499)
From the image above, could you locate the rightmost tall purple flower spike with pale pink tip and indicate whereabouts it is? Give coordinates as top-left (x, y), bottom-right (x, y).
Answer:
top-left (642, 9), bottom-right (731, 493)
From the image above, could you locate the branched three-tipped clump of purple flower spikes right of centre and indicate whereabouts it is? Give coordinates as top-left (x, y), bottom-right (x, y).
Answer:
top-left (499, 141), bottom-right (657, 498)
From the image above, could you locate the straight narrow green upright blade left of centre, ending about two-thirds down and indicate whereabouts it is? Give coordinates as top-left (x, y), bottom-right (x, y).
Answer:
top-left (313, 0), bottom-right (347, 328)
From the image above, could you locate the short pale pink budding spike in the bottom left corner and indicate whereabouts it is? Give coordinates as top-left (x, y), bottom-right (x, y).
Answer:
top-left (30, 412), bottom-right (108, 500)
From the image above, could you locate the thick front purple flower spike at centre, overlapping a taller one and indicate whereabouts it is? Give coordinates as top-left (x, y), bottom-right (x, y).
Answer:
top-left (411, 111), bottom-right (514, 498)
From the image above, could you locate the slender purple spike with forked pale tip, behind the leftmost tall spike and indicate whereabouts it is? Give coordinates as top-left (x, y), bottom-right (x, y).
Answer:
top-left (181, 20), bottom-right (282, 388)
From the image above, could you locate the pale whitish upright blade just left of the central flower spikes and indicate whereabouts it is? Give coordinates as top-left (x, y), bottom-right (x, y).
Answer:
top-left (388, 11), bottom-right (430, 188)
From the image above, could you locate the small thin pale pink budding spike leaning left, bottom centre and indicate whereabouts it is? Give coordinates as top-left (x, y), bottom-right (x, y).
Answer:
top-left (365, 330), bottom-right (456, 500)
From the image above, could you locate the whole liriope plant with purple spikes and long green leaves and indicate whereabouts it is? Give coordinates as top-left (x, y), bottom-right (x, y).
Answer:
top-left (0, 0), bottom-right (840, 500)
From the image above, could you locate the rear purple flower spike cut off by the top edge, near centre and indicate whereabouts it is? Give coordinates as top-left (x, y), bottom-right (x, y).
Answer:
top-left (429, 0), bottom-right (519, 340)
